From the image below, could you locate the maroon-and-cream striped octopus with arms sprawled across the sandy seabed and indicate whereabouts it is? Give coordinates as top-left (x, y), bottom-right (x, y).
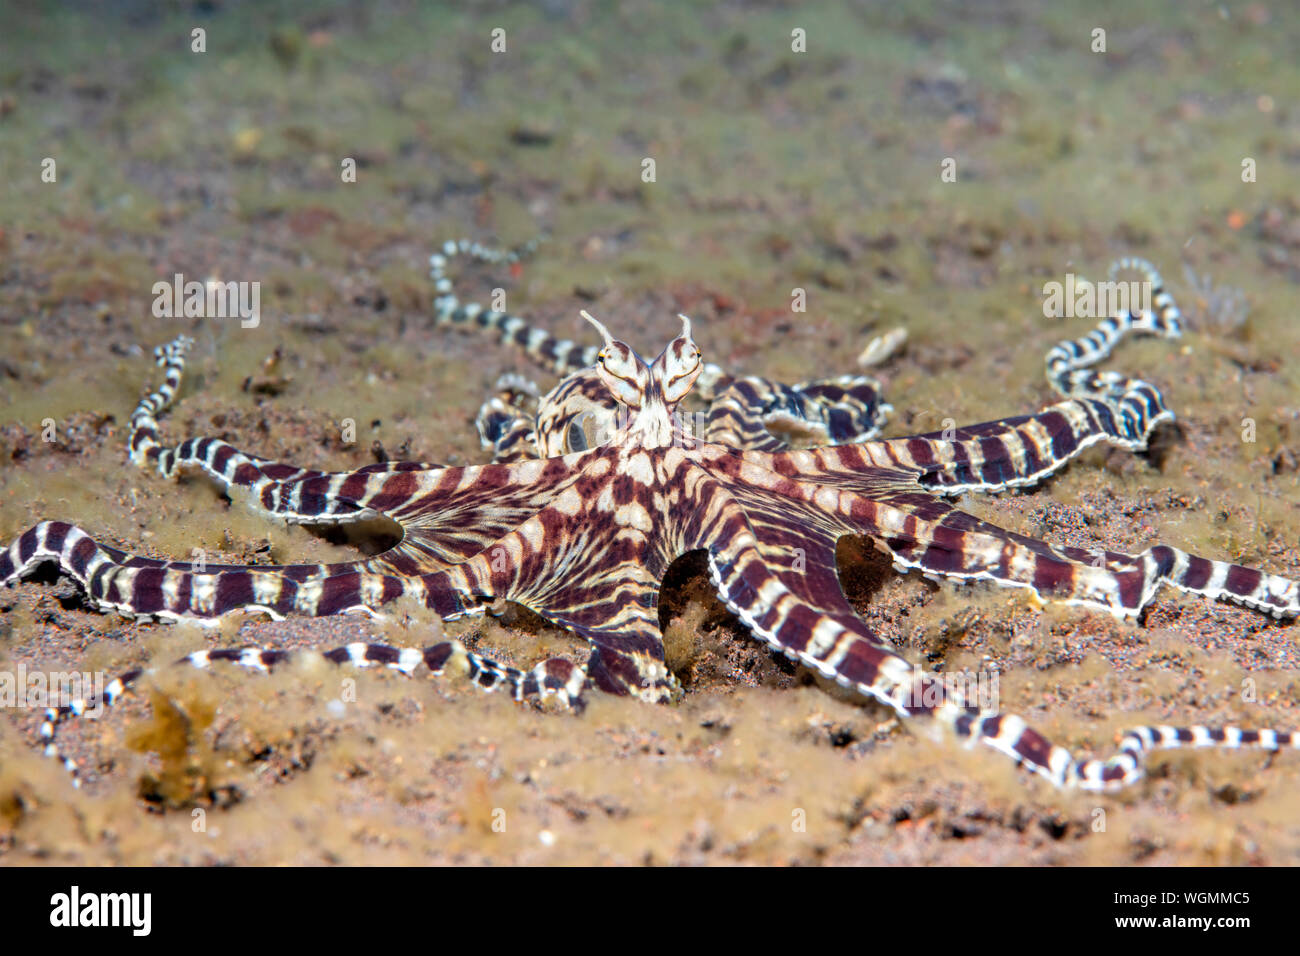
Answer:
top-left (0, 256), bottom-right (1300, 790)
